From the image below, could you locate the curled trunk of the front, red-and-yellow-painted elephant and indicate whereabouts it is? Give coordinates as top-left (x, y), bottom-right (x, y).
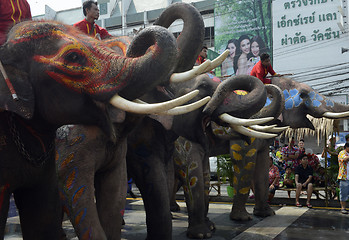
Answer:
top-left (96, 26), bottom-right (177, 100)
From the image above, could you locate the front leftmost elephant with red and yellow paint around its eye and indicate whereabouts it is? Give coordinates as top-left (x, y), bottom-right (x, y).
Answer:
top-left (0, 21), bottom-right (177, 240)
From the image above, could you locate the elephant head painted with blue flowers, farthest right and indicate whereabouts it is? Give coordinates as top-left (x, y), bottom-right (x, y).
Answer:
top-left (272, 77), bottom-right (349, 130)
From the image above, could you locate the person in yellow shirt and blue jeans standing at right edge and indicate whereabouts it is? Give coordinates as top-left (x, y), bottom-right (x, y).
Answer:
top-left (337, 142), bottom-right (349, 214)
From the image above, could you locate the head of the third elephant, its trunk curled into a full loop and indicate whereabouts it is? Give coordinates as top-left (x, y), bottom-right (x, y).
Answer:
top-left (173, 74), bottom-right (272, 141)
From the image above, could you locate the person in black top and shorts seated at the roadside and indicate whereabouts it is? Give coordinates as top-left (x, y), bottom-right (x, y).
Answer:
top-left (295, 154), bottom-right (313, 208)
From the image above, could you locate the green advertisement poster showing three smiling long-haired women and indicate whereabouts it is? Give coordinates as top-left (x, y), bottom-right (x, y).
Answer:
top-left (215, 0), bottom-right (272, 76)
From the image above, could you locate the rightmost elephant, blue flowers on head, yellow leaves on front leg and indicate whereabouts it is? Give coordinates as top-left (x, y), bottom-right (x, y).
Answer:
top-left (230, 77), bottom-right (349, 220)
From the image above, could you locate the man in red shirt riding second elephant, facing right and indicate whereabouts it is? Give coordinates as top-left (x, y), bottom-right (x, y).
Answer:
top-left (74, 1), bottom-right (112, 40)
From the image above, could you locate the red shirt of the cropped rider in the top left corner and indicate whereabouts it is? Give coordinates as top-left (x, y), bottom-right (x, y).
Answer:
top-left (0, 0), bottom-right (32, 45)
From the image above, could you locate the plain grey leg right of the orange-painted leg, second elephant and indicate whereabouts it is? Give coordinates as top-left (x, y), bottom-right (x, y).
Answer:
top-left (95, 141), bottom-right (127, 240)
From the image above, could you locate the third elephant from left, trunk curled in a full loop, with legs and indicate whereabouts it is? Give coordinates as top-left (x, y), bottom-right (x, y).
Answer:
top-left (127, 74), bottom-right (275, 239)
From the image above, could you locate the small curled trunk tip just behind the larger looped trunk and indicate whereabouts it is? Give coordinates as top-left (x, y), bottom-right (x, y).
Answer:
top-left (251, 84), bottom-right (285, 118)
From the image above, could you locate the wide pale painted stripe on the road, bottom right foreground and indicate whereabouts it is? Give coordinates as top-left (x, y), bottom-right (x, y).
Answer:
top-left (233, 207), bottom-right (308, 240)
